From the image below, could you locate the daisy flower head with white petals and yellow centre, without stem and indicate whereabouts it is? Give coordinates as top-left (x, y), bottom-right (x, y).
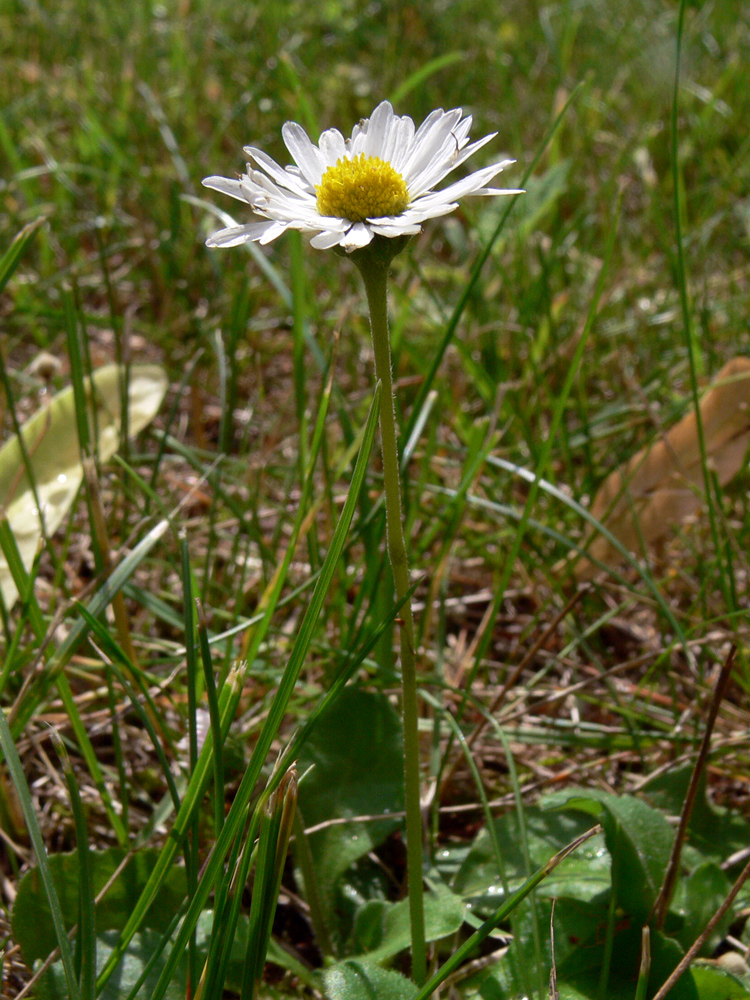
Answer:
top-left (203, 101), bottom-right (521, 253)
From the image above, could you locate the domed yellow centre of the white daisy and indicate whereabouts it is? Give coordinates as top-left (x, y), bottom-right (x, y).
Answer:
top-left (315, 153), bottom-right (409, 222)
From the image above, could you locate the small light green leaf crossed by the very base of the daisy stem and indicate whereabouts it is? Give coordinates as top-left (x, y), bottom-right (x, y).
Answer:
top-left (353, 887), bottom-right (464, 963)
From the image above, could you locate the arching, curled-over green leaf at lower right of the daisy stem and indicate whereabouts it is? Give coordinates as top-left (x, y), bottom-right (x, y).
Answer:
top-left (544, 789), bottom-right (674, 923)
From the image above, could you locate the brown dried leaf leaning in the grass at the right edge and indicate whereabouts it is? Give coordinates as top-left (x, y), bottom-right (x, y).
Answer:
top-left (575, 358), bottom-right (750, 580)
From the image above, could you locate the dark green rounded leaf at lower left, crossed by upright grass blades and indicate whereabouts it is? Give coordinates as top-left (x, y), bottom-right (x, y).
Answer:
top-left (11, 847), bottom-right (187, 967)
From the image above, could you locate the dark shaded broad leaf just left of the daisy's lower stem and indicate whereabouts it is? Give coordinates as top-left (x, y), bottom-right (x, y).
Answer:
top-left (299, 687), bottom-right (404, 928)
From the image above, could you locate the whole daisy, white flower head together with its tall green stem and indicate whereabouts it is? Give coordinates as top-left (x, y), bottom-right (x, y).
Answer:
top-left (203, 101), bottom-right (521, 985)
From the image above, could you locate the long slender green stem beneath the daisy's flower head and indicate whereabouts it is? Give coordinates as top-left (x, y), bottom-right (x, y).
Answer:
top-left (356, 253), bottom-right (427, 986)
